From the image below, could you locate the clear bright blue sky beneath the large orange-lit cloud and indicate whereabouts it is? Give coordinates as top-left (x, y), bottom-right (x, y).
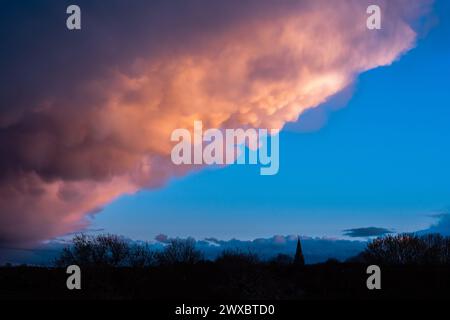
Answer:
top-left (93, 1), bottom-right (450, 240)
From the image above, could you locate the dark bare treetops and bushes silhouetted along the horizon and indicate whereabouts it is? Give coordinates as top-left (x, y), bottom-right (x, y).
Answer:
top-left (55, 234), bottom-right (450, 267)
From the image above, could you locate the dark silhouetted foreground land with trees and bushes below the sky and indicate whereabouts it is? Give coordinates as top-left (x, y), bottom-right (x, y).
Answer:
top-left (0, 235), bottom-right (450, 300)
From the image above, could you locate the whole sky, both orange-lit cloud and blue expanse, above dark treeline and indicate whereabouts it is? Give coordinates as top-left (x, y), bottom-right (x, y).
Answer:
top-left (0, 0), bottom-right (450, 248)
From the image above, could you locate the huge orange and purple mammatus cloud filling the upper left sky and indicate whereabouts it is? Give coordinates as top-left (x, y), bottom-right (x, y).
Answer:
top-left (0, 0), bottom-right (436, 243)
